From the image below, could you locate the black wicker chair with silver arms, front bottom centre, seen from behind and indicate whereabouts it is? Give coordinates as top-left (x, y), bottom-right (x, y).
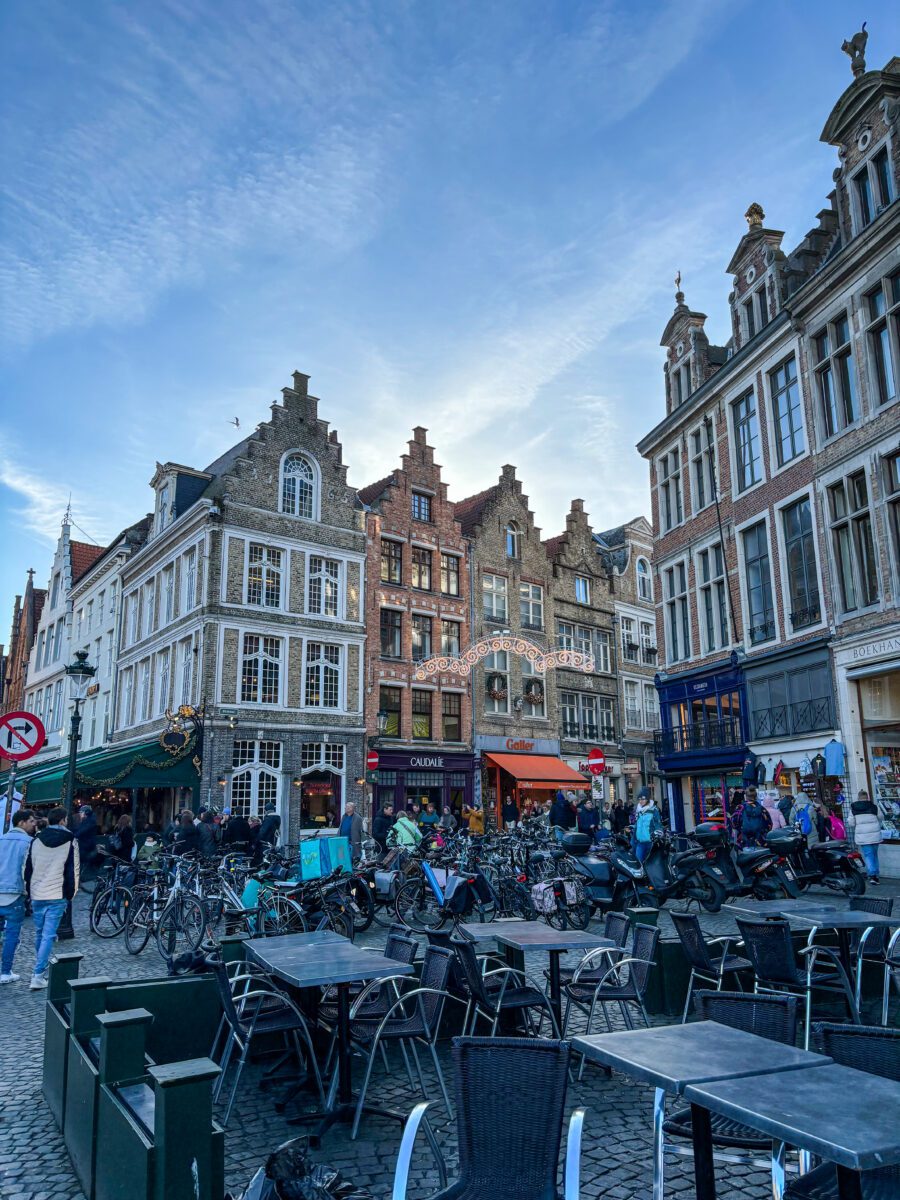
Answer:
top-left (391, 1038), bottom-right (584, 1200)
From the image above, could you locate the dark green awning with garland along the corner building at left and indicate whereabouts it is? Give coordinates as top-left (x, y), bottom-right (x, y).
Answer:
top-left (0, 736), bottom-right (200, 804)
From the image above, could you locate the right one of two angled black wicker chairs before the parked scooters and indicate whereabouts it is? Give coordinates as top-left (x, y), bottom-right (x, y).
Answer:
top-left (737, 918), bottom-right (859, 1050)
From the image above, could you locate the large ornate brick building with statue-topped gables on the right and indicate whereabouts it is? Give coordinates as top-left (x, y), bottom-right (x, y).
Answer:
top-left (638, 42), bottom-right (900, 849)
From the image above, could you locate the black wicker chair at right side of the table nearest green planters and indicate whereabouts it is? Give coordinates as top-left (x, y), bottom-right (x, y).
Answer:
top-left (345, 946), bottom-right (455, 1139)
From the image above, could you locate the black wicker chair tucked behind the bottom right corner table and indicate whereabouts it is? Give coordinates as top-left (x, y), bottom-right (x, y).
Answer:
top-left (785, 1021), bottom-right (900, 1200)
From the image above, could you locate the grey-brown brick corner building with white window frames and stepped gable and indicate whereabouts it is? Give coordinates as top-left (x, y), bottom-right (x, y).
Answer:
top-left (115, 372), bottom-right (365, 840)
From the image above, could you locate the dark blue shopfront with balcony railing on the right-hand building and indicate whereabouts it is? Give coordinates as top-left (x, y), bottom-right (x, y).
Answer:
top-left (654, 654), bottom-right (748, 830)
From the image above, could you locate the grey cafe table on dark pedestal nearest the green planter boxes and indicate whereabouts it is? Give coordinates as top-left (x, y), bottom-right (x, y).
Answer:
top-left (245, 930), bottom-right (414, 1136)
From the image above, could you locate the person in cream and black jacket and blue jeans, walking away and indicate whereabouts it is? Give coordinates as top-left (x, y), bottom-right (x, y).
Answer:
top-left (25, 808), bottom-right (80, 991)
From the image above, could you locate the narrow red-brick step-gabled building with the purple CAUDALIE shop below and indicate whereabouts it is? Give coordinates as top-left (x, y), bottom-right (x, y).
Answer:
top-left (359, 426), bottom-right (473, 814)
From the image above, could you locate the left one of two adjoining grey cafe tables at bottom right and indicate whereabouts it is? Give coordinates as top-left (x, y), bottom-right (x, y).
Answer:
top-left (571, 1021), bottom-right (832, 1200)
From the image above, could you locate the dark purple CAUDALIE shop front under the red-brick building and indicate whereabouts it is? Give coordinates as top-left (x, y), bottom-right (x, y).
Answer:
top-left (374, 748), bottom-right (475, 820)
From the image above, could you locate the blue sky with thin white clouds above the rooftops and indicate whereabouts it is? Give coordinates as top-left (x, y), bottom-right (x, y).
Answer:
top-left (0, 0), bottom-right (900, 641)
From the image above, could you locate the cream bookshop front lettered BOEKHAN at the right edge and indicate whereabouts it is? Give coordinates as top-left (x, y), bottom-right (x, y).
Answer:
top-left (834, 626), bottom-right (900, 877)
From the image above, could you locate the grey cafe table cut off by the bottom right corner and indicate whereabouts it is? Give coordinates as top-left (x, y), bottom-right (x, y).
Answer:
top-left (685, 1063), bottom-right (900, 1200)
